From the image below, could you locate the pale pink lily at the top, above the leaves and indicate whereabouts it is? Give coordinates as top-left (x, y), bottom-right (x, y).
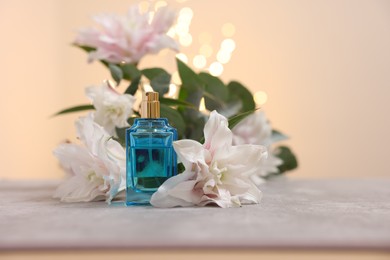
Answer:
top-left (75, 5), bottom-right (178, 64)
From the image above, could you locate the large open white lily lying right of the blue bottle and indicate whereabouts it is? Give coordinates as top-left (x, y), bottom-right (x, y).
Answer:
top-left (150, 111), bottom-right (267, 208)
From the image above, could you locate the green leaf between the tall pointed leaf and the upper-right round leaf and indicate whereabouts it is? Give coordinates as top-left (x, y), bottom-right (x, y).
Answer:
top-left (199, 72), bottom-right (229, 111)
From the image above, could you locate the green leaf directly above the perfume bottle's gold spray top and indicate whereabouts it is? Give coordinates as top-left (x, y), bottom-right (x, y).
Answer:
top-left (142, 68), bottom-right (171, 97)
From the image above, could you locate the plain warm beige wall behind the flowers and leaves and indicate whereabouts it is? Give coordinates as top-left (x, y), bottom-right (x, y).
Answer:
top-left (0, 0), bottom-right (390, 179)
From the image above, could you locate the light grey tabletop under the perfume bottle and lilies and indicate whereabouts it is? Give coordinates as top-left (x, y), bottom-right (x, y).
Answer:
top-left (0, 179), bottom-right (390, 250)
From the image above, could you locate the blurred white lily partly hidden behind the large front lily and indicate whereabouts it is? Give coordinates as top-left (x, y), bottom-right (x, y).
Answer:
top-left (232, 111), bottom-right (283, 182)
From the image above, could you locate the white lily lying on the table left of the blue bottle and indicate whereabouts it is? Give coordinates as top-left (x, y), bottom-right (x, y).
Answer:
top-left (53, 115), bottom-right (126, 203)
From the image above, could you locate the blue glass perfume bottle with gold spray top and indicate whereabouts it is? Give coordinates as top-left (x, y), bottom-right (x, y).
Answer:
top-left (126, 92), bottom-right (177, 205)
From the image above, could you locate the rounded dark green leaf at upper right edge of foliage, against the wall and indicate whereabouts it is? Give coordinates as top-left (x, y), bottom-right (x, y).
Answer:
top-left (227, 81), bottom-right (256, 112)
